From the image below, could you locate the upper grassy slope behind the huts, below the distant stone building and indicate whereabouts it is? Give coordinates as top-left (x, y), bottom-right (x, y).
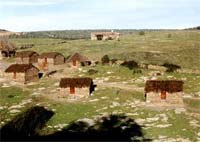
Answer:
top-left (12, 31), bottom-right (200, 69)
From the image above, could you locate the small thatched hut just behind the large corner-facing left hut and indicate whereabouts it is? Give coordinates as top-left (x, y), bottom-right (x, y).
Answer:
top-left (16, 51), bottom-right (39, 64)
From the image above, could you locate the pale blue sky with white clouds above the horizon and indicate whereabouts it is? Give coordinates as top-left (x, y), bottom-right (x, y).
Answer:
top-left (0, 0), bottom-right (200, 32)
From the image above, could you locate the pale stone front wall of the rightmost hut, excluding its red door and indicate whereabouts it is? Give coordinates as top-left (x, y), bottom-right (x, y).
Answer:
top-left (146, 92), bottom-right (183, 104)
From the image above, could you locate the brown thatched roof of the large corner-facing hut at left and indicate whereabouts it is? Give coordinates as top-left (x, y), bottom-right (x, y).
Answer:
top-left (5, 64), bottom-right (39, 73)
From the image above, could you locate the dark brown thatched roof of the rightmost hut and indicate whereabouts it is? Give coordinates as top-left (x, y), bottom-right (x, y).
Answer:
top-left (145, 80), bottom-right (184, 93)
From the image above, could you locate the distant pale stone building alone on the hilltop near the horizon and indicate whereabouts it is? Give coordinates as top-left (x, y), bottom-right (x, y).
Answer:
top-left (91, 32), bottom-right (120, 40)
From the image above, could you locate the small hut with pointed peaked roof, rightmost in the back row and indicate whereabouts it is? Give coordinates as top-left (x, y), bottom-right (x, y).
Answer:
top-left (68, 53), bottom-right (91, 68)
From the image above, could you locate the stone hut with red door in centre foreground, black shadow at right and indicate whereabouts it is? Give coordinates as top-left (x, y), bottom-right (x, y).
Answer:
top-left (60, 78), bottom-right (94, 97)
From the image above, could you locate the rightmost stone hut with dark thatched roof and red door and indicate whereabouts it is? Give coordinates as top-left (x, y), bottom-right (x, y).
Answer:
top-left (145, 80), bottom-right (184, 104)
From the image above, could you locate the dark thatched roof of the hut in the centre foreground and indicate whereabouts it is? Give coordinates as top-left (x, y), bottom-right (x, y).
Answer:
top-left (60, 78), bottom-right (92, 88)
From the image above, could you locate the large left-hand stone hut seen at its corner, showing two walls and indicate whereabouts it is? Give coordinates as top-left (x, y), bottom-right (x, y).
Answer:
top-left (5, 64), bottom-right (39, 84)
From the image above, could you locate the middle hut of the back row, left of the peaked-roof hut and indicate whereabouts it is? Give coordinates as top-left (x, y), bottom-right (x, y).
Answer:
top-left (38, 52), bottom-right (65, 70)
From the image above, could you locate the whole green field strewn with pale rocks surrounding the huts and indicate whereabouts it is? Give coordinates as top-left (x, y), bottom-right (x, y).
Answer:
top-left (0, 31), bottom-right (200, 141)
